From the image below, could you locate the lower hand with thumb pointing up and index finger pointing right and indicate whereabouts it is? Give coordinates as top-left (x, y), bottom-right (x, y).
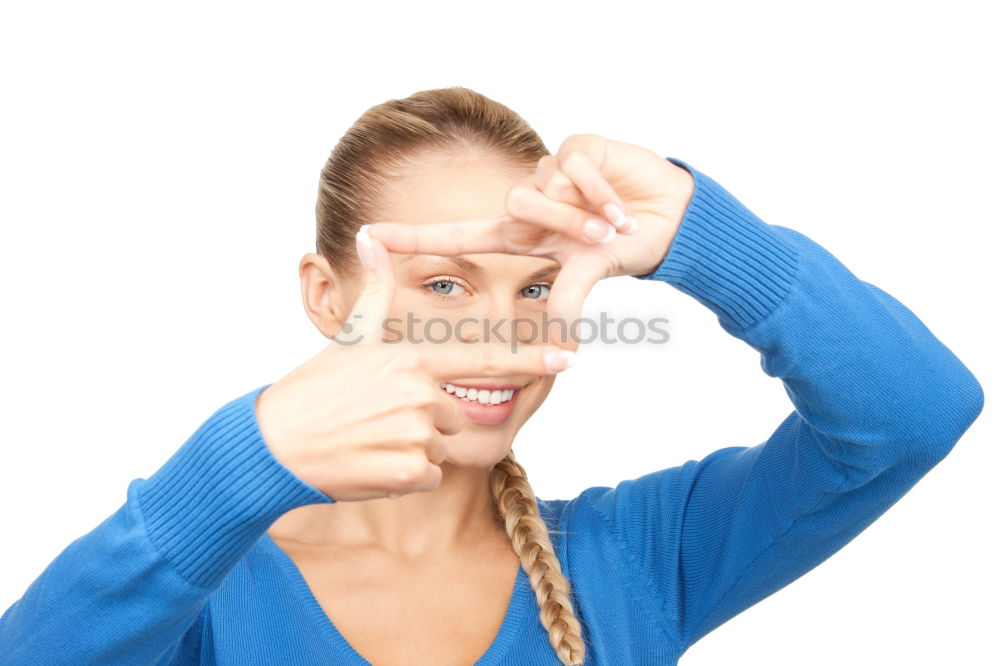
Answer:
top-left (256, 226), bottom-right (572, 501)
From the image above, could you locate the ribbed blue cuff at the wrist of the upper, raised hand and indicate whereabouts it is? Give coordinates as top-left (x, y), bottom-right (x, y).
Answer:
top-left (634, 157), bottom-right (798, 333)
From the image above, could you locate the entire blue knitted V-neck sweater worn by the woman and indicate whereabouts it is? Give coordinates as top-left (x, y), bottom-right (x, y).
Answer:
top-left (0, 158), bottom-right (983, 666)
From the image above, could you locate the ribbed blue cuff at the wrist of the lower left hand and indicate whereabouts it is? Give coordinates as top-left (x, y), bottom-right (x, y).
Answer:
top-left (138, 384), bottom-right (334, 588)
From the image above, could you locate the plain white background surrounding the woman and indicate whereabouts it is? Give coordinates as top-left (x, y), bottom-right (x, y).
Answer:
top-left (0, 1), bottom-right (1000, 666)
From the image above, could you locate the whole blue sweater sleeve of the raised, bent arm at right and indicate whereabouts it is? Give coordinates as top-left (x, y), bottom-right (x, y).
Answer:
top-left (584, 158), bottom-right (984, 650)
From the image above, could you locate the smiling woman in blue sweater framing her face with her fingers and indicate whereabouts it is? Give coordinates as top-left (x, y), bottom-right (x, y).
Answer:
top-left (0, 88), bottom-right (983, 666)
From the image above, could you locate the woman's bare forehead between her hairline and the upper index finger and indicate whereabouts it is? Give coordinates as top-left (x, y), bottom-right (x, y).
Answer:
top-left (379, 157), bottom-right (530, 224)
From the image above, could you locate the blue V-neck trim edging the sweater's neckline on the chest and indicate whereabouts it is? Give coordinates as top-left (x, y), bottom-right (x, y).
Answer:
top-left (260, 532), bottom-right (531, 666)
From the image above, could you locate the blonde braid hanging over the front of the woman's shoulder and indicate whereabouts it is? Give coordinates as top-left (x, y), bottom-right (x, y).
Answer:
top-left (490, 450), bottom-right (584, 666)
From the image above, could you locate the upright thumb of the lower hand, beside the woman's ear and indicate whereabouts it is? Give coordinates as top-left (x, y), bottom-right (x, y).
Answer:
top-left (333, 224), bottom-right (396, 346)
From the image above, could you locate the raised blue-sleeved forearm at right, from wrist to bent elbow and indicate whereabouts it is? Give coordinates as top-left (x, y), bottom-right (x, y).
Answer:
top-left (641, 160), bottom-right (983, 456)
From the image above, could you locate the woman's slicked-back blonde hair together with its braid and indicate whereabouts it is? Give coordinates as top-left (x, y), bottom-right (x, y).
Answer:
top-left (316, 86), bottom-right (584, 666)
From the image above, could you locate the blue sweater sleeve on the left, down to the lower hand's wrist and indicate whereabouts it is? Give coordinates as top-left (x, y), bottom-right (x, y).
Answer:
top-left (0, 385), bottom-right (334, 666)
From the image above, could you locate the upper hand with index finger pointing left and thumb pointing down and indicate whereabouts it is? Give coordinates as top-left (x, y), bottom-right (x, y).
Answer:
top-left (369, 134), bottom-right (694, 349)
